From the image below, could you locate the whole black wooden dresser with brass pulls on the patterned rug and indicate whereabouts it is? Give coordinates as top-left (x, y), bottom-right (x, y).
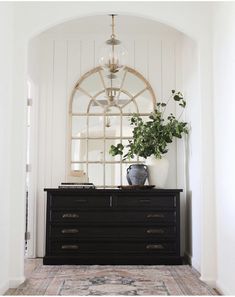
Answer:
top-left (43, 189), bottom-right (182, 265)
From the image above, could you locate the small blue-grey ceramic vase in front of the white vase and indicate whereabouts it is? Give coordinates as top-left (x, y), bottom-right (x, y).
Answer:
top-left (126, 164), bottom-right (148, 185)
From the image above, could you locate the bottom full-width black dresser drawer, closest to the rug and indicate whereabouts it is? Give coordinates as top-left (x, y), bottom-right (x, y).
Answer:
top-left (51, 241), bottom-right (176, 254)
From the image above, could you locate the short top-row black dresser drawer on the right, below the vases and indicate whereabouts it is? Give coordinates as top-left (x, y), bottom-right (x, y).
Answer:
top-left (116, 194), bottom-right (176, 209)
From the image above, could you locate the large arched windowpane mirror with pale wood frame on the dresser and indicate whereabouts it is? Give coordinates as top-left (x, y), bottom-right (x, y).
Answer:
top-left (69, 67), bottom-right (156, 187)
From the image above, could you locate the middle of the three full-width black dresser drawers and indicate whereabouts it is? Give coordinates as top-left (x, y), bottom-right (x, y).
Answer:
top-left (51, 225), bottom-right (176, 239)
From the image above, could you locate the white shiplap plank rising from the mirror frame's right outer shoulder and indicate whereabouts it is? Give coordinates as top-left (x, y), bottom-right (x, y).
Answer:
top-left (148, 39), bottom-right (162, 102)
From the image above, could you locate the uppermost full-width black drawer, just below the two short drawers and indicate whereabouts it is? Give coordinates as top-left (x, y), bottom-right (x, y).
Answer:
top-left (50, 210), bottom-right (176, 224)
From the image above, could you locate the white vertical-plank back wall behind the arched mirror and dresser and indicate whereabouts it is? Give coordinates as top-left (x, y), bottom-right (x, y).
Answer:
top-left (32, 15), bottom-right (185, 257)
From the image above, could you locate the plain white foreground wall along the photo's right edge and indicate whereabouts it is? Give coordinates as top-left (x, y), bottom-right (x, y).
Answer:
top-left (213, 2), bottom-right (235, 295)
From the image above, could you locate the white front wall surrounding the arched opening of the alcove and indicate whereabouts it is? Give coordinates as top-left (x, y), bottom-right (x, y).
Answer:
top-left (1, 2), bottom-right (216, 292)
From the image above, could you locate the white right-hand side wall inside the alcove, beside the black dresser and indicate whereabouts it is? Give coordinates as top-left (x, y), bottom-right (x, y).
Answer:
top-left (182, 38), bottom-right (202, 271)
